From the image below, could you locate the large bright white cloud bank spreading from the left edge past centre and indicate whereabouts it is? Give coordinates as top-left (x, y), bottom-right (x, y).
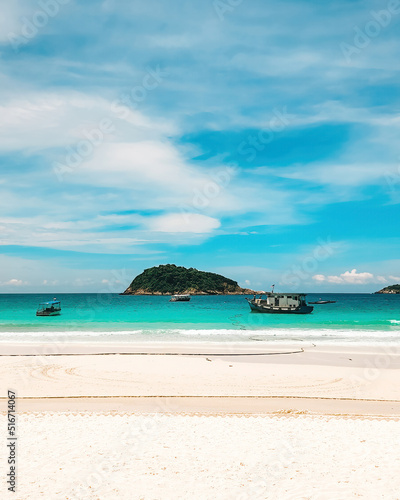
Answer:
top-left (0, 85), bottom-right (308, 253)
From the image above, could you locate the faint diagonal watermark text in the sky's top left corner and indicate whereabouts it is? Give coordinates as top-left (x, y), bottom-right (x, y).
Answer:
top-left (8, 0), bottom-right (71, 52)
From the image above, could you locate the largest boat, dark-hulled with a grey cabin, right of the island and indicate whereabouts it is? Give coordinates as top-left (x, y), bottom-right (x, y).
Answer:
top-left (246, 292), bottom-right (314, 314)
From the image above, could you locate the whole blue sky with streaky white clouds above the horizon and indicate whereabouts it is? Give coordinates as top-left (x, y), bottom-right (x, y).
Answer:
top-left (0, 0), bottom-right (400, 293)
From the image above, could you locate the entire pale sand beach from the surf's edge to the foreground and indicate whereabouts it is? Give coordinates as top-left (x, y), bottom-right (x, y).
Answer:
top-left (0, 343), bottom-right (400, 500)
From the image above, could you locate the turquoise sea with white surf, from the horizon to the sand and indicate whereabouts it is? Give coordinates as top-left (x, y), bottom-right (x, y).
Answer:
top-left (0, 294), bottom-right (400, 344)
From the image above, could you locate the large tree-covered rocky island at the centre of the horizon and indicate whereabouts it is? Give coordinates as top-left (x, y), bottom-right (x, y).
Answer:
top-left (121, 264), bottom-right (255, 295)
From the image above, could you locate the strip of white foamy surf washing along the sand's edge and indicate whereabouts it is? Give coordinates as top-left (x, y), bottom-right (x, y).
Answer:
top-left (0, 320), bottom-right (400, 352)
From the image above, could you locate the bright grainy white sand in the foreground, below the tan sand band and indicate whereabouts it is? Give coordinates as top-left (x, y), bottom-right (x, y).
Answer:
top-left (1, 412), bottom-right (400, 500)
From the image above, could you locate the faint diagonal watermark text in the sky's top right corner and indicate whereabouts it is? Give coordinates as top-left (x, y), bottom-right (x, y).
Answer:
top-left (340, 0), bottom-right (400, 64)
